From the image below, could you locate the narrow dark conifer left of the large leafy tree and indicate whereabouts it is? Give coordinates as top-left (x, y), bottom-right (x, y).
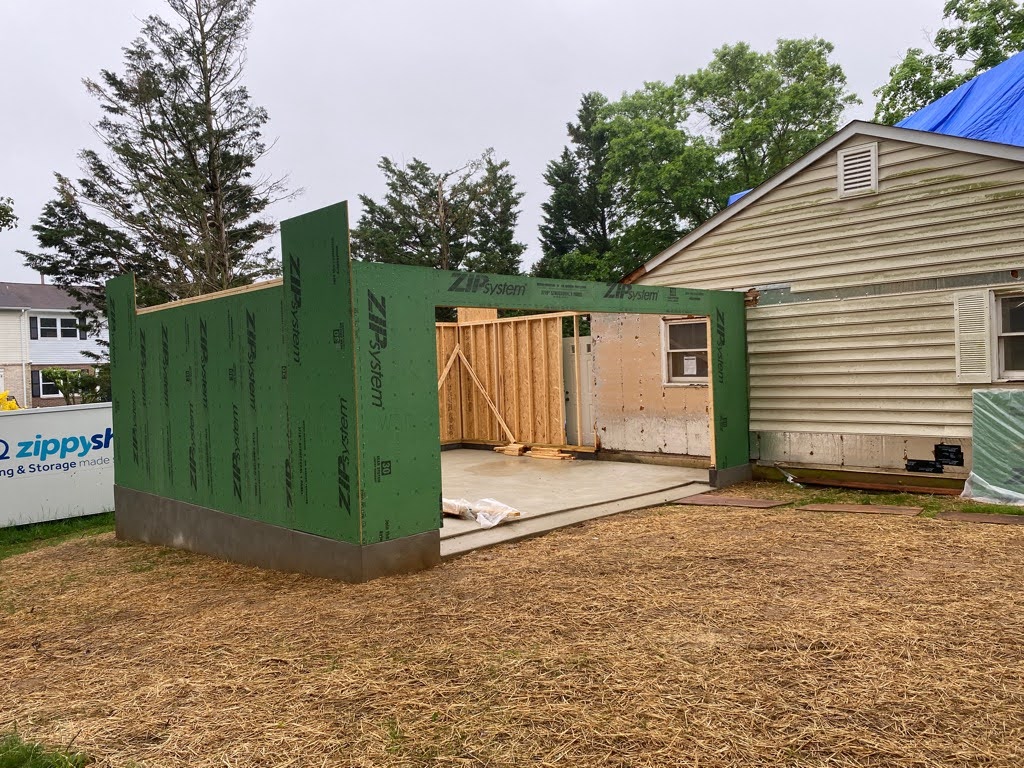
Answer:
top-left (534, 92), bottom-right (613, 280)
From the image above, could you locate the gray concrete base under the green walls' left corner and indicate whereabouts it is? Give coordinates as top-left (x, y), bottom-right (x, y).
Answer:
top-left (114, 485), bottom-right (440, 583)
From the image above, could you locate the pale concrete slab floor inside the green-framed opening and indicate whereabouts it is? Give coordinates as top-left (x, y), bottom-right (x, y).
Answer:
top-left (441, 450), bottom-right (709, 557)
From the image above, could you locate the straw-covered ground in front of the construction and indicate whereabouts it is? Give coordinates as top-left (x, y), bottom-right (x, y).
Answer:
top-left (0, 507), bottom-right (1024, 767)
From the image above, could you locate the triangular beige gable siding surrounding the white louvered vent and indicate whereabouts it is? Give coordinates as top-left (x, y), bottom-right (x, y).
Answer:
top-left (641, 137), bottom-right (1024, 292)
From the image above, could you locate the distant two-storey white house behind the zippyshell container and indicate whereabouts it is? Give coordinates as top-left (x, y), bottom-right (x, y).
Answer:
top-left (0, 283), bottom-right (106, 408)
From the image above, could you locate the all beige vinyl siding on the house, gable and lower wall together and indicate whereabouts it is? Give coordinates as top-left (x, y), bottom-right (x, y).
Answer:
top-left (639, 136), bottom-right (1024, 456)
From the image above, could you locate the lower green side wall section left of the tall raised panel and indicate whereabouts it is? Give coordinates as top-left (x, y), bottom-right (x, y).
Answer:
top-left (108, 278), bottom-right (292, 529)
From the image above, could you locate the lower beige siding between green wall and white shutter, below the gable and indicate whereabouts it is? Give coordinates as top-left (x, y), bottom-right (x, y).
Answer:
top-left (746, 291), bottom-right (972, 437)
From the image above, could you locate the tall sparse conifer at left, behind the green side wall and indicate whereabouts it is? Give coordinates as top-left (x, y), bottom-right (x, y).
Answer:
top-left (22, 0), bottom-right (287, 319)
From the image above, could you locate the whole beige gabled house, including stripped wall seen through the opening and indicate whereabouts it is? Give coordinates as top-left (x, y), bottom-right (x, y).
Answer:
top-left (592, 122), bottom-right (1024, 485)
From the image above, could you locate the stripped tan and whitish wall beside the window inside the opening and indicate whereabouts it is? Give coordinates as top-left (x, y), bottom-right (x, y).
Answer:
top-left (591, 314), bottom-right (711, 457)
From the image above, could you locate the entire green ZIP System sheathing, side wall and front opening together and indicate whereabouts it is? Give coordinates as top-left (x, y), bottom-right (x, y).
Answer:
top-left (108, 204), bottom-right (749, 581)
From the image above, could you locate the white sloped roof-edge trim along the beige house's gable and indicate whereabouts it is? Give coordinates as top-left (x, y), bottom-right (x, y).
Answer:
top-left (622, 120), bottom-right (1024, 283)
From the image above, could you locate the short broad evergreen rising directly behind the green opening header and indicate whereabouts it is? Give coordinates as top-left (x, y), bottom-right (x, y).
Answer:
top-left (352, 150), bottom-right (525, 274)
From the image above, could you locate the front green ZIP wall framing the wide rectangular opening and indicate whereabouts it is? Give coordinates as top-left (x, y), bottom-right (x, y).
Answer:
top-left (352, 262), bottom-right (750, 543)
